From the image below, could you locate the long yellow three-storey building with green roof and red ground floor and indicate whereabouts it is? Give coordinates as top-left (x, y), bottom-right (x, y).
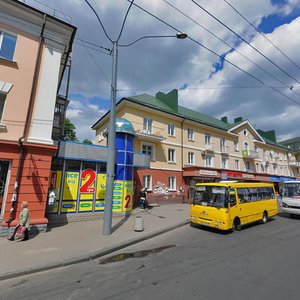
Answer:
top-left (92, 90), bottom-right (300, 202)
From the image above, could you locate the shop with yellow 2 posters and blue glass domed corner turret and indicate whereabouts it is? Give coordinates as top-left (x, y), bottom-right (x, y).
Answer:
top-left (47, 119), bottom-right (149, 220)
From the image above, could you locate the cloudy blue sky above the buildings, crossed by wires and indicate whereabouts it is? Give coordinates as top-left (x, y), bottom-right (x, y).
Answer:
top-left (26, 0), bottom-right (300, 140)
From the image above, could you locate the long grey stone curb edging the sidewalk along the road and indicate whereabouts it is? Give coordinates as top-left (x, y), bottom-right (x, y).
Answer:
top-left (0, 220), bottom-right (190, 281)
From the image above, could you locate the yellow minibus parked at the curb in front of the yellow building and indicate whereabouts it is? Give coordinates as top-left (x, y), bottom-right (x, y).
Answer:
top-left (190, 182), bottom-right (278, 231)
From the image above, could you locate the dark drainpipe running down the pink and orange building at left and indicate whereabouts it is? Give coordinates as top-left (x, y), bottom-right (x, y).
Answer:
top-left (6, 14), bottom-right (47, 227)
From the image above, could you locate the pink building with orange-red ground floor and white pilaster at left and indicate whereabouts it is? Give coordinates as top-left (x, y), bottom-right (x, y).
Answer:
top-left (0, 0), bottom-right (76, 236)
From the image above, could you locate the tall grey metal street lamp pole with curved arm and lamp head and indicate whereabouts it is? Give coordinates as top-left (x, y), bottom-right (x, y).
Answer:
top-left (103, 32), bottom-right (187, 235)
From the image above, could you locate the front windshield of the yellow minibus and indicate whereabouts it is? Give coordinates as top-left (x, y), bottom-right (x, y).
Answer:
top-left (193, 185), bottom-right (227, 207)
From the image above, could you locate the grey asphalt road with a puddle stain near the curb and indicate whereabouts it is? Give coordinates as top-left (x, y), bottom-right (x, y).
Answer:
top-left (0, 211), bottom-right (300, 300)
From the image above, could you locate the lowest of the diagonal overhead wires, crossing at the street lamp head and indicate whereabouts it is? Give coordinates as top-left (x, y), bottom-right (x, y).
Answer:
top-left (126, 0), bottom-right (300, 106)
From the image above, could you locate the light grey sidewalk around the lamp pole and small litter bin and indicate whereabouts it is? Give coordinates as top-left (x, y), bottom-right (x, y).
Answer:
top-left (0, 204), bottom-right (189, 280)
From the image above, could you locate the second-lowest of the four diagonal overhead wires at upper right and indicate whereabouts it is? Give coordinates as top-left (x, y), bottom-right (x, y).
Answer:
top-left (162, 0), bottom-right (300, 96)
